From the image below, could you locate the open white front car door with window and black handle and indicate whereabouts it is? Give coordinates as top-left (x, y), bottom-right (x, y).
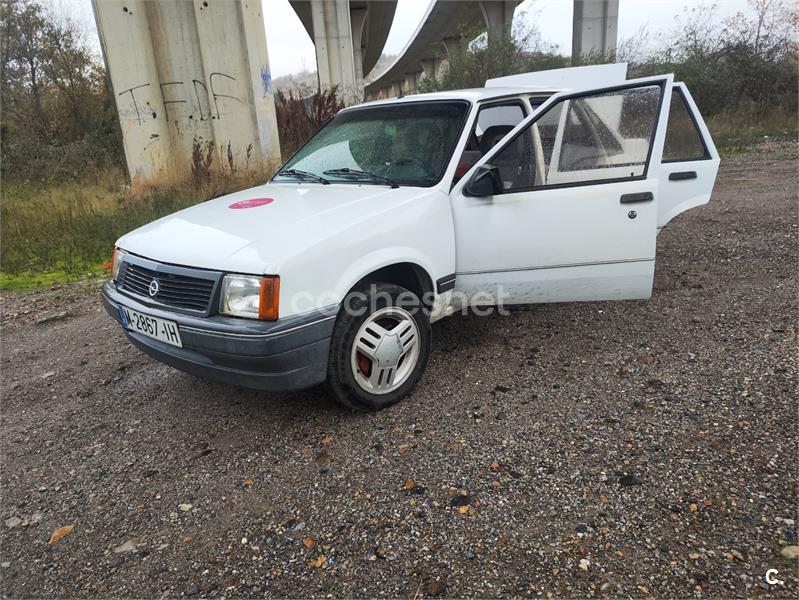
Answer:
top-left (452, 76), bottom-right (672, 304)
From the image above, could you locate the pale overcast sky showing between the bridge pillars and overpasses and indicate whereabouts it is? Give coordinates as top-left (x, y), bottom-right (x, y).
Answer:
top-left (64, 0), bottom-right (749, 77)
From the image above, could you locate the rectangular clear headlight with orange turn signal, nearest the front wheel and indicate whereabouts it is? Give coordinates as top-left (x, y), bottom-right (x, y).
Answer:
top-left (219, 275), bottom-right (280, 321)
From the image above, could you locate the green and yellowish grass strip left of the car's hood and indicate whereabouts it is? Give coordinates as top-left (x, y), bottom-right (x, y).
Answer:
top-left (0, 166), bottom-right (272, 288)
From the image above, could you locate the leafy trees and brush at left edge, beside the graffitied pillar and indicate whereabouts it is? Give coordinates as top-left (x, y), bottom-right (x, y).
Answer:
top-left (0, 0), bottom-right (124, 181)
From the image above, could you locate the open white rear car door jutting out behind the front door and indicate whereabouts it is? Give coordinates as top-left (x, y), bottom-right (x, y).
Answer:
top-left (657, 82), bottom-right (719, 229)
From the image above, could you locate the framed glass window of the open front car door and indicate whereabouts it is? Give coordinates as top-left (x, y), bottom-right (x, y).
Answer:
top-left (490, 84), bottom-right (662, 192)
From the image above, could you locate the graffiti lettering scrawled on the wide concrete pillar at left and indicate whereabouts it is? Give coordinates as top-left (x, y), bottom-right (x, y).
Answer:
top-left (118, 71), bottom-right (242, 125)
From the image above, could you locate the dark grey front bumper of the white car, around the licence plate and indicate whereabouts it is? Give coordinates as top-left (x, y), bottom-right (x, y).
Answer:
top-left (102, 281), bottom-right (337, 391)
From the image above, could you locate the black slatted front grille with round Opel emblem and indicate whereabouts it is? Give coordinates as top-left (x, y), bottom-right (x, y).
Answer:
top-left (117, 262), bottom-right (216, 313)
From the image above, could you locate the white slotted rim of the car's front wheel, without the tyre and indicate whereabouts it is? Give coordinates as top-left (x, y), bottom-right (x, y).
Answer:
top-left (350, 306), bottom-right (419, 394)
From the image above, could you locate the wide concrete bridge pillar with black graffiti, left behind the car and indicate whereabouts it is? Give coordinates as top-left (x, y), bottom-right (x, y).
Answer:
top-left (92, 0), bottom-right (280, 185)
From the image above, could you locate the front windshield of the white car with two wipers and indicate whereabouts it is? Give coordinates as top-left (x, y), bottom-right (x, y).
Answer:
top-left (274, 101), bottom-right (469, 187)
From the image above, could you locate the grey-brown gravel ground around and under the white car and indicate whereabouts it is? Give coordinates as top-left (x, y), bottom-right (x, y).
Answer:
top-left (0, 145), bottom-right (799, 598)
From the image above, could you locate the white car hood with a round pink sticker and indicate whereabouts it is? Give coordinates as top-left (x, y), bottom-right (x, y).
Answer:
top-left (117, 183), bottom-right (429, 274)
